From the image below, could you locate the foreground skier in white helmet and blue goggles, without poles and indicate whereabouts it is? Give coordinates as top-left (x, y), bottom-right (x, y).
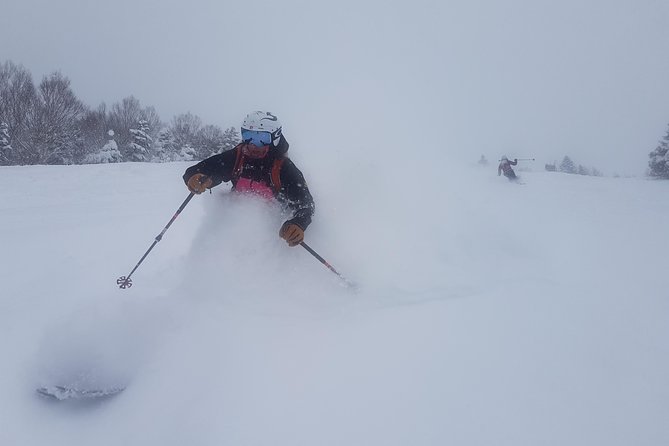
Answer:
top-left (183, 111), bottom-right (315, 246)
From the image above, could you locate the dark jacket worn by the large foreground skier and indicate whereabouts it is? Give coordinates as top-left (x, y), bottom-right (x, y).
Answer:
top-left (183, 135), bottom-right (316, 229)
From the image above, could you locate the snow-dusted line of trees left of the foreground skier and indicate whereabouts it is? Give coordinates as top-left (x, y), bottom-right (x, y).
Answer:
top-left (0, 61), bottom-right (240, 165)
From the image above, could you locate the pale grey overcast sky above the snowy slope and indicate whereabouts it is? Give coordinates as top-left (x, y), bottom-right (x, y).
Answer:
top-left (0, 0), bottom-right (669, 174)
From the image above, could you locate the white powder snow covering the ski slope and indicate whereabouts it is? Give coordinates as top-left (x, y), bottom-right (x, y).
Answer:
top-left (0, 159), bottom-right (669, 446)
